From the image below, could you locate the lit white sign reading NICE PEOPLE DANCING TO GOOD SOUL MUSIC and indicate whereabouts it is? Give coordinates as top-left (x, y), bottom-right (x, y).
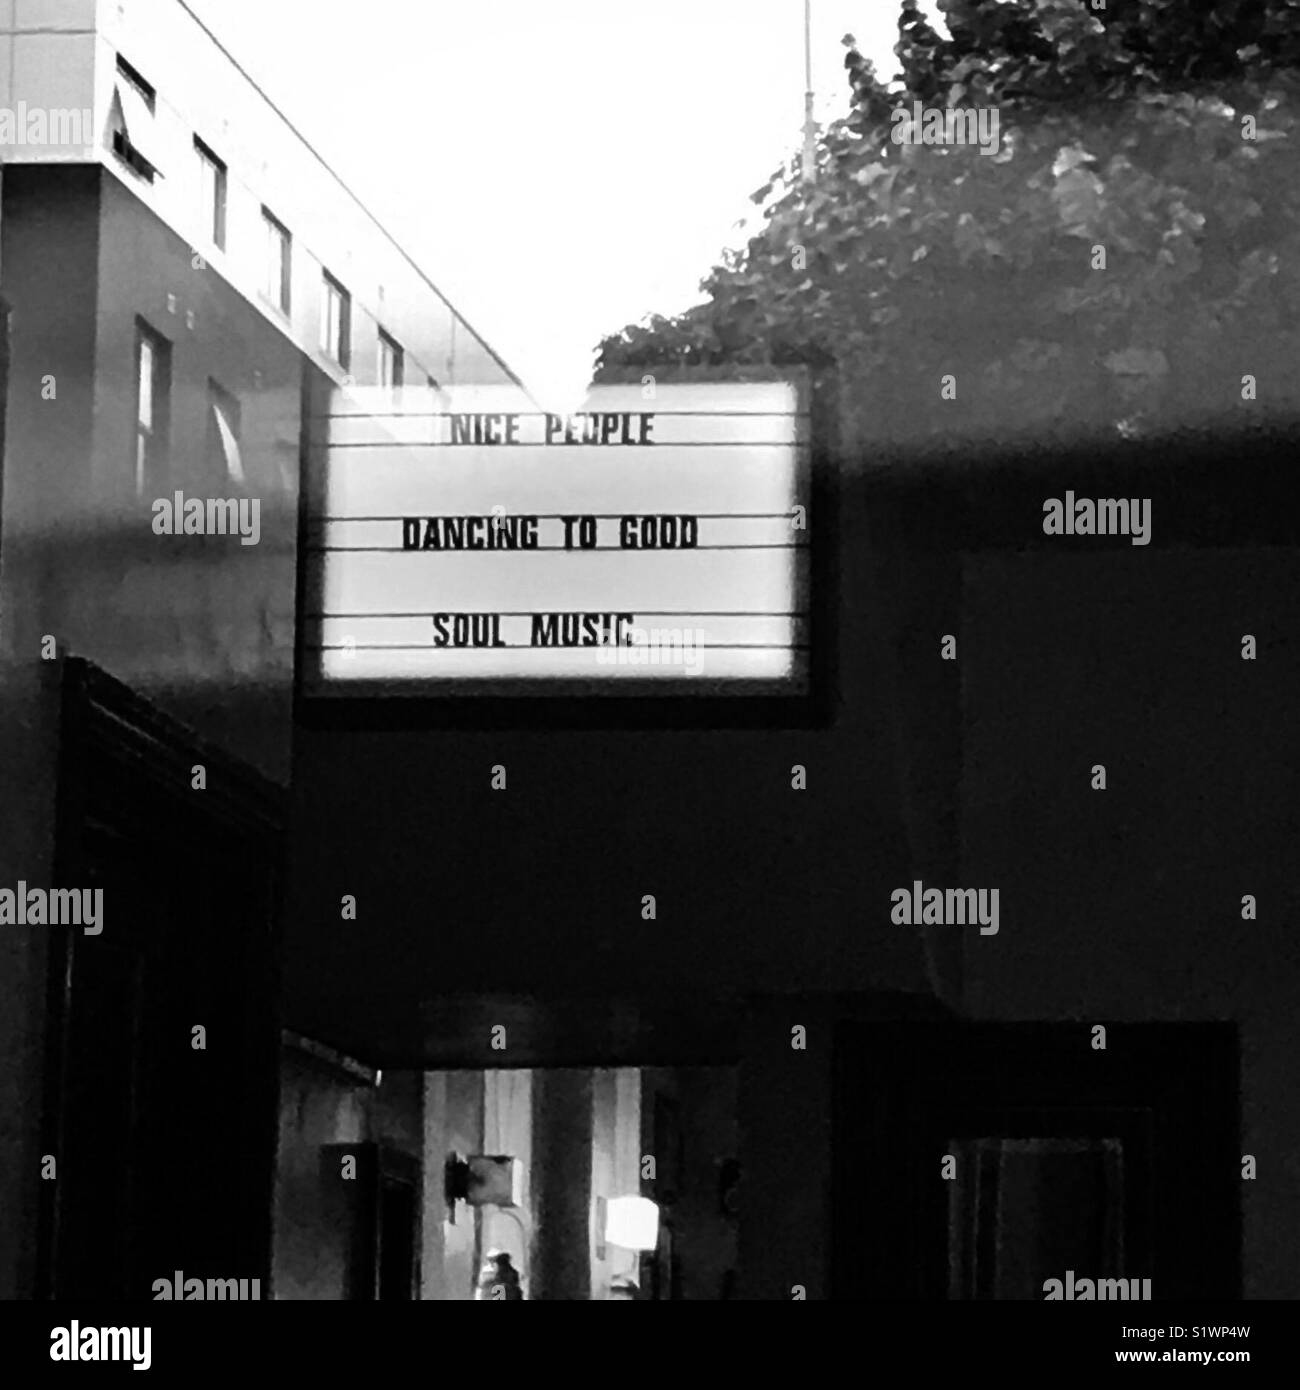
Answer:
top-left (303, 382), bottom-right (809, 696)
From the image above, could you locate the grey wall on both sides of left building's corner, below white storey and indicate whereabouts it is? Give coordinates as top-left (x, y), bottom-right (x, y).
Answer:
top-left (0, 167), bottom-right (303, 781)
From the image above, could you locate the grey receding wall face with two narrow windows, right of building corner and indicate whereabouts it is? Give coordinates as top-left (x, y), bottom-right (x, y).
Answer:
top-left (86, 166), bottom-right (303, 780)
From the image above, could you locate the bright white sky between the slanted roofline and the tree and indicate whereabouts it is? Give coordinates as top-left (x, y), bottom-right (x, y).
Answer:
top-left (189, 0), bottom-right (941, 402)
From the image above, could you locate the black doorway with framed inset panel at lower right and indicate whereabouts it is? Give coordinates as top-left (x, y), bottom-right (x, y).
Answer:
top-left (831, 1023), bottom-right (1242, 1300)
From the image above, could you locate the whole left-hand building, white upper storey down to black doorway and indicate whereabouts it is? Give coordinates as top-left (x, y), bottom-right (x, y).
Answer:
top-left (0, 0), bottom-right (516, 1297)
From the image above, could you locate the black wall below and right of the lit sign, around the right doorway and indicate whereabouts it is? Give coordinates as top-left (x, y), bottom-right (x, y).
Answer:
top-left (279, 391), bottom-right (1300, 1298)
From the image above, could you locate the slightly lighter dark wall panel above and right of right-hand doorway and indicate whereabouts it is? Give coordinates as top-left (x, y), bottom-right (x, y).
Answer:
top-left (962, 544), bottom-right (1300, 1298)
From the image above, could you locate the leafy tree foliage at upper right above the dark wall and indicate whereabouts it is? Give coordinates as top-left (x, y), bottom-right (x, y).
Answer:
top-left (598, 0), bottom-right (1300, 438)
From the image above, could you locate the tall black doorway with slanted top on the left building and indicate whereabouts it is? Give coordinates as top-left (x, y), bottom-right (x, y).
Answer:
top-left (38, 660), bottom-right (282, 1298)
